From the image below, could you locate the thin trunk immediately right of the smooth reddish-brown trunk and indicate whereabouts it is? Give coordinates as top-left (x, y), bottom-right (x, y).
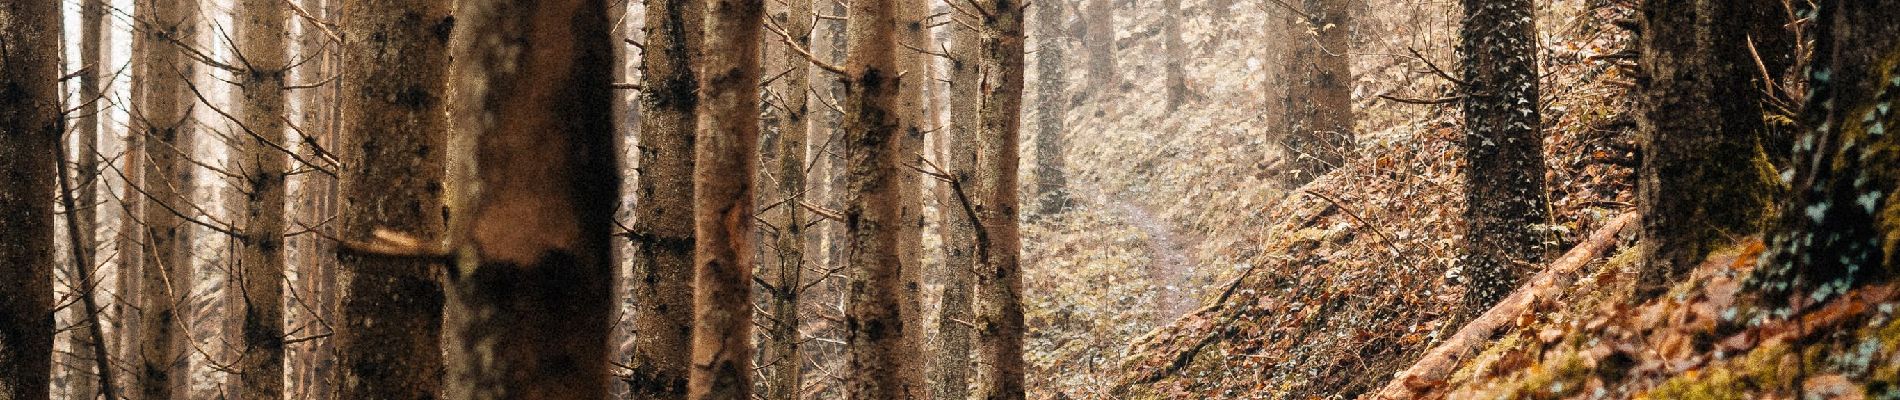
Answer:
top-left (762, 0), bottom-right (815, 400)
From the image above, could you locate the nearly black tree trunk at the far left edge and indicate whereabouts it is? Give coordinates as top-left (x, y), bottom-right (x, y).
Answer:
top-left (0, 0), bottom-right (65, 400)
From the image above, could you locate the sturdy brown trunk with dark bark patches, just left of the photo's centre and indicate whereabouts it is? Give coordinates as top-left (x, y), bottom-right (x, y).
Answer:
top-left (844, 0), bottom-right (925, 398)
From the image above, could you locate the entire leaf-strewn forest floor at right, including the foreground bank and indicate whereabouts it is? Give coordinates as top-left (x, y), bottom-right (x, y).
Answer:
top-left (1024, 0), bottom-right (1900, 398)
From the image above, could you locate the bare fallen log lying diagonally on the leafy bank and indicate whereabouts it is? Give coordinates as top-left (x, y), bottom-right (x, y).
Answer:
top-left (1364, 212), bottom-right (1638, 400)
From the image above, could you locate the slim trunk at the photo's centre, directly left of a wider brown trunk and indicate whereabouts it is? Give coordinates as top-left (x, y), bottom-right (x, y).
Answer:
top-left (929, 13), bottom-right (982, 398)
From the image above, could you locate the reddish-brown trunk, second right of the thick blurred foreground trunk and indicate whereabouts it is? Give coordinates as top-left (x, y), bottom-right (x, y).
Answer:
top-left (686, 0), bottom-right (766, 400)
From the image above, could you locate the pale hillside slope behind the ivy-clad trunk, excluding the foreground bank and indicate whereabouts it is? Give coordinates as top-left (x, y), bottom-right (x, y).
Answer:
top-left (1026, 0), bottom-right (1634, 398)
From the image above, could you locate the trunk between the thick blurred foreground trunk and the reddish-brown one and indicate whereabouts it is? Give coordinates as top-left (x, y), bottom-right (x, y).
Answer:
top-left (629, 0), bottom-right (705, 400)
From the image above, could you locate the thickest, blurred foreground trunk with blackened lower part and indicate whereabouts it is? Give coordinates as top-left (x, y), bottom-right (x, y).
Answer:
top-left (443, 0), bottom-right (615, 400)
